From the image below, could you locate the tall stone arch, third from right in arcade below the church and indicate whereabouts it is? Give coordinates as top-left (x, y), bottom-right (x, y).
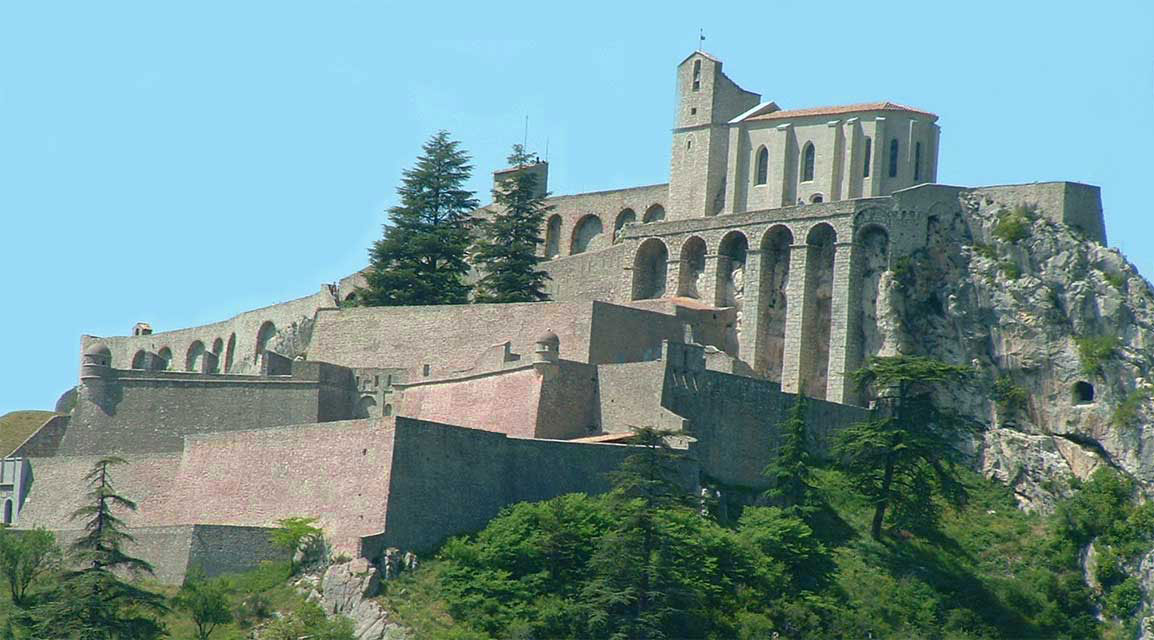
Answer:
top-left (754, 225), bottom-right (793, 383)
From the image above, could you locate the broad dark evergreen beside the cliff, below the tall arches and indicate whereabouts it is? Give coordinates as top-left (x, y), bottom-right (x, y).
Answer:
top-left (834, 355), bottom-right (972, 540)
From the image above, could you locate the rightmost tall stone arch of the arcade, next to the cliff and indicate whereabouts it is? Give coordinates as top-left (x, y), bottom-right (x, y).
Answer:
top-left (849, 224), bottom-right (890, 396)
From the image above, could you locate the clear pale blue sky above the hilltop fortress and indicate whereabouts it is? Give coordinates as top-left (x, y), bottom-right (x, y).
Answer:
top-left (0, 0), bottom-right (1154, 414)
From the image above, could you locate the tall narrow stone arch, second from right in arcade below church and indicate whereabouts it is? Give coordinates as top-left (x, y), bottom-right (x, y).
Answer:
top-left (799, 223), bottom-right (838, 400)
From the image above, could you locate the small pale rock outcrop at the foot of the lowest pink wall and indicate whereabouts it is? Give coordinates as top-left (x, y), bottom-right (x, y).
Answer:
top-left (310, 558), bottom-right (407, 640)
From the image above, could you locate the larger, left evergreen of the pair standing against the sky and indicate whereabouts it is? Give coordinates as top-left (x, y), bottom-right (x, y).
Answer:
top-left (357, 131), bottom-right (478, 307)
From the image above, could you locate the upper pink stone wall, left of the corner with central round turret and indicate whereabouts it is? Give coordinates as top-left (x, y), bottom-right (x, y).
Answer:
top-left (397, 367), bottom-right (541, 438)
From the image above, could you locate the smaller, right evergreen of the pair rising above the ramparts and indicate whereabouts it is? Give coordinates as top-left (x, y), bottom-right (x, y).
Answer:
top-left (473, 144), bottom-right (553, 302)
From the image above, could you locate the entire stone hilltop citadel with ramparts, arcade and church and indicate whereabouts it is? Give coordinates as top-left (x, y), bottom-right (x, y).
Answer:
top-left (0, 51), bottom-right (1106, 582)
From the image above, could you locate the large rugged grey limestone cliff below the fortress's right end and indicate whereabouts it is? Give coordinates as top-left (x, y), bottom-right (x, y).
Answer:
top-left (874, 193), bottom-right (1154, 511)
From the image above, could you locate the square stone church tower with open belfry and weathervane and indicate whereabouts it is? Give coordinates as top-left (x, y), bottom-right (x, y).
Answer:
top-left (668, 51), bottom-right (760, 219)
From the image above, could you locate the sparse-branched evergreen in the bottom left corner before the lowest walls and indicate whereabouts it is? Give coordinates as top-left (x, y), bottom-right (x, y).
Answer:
top-left (20, 458), bottom-right (167, 640)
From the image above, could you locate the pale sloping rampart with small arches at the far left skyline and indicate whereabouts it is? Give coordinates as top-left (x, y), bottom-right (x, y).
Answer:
top-left (81, 286), bottom-right (337, 374)
